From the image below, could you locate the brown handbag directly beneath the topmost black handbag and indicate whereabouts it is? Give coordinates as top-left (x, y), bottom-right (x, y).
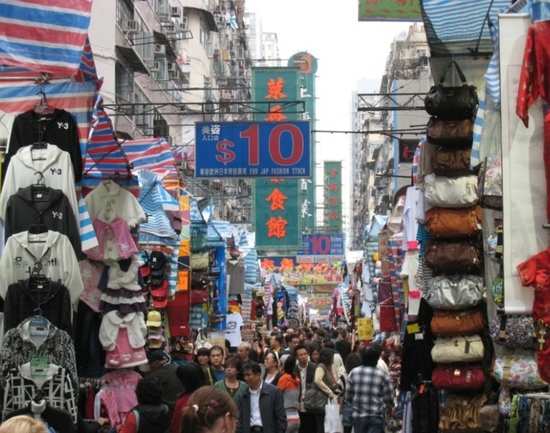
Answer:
top-left (428, 117), bottom-right (474, 149)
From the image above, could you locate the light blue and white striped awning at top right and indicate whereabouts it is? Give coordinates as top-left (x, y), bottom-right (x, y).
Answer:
top-left (421, 0), bottom-right (510, 57)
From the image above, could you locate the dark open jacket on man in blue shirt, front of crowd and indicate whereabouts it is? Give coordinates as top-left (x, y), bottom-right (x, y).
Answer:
top-left (237, 383), bottom-right (287, 433)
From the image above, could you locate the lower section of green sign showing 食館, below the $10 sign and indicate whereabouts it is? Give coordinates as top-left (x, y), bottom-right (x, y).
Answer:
top-left (254, 179), bottom-right (302, 251)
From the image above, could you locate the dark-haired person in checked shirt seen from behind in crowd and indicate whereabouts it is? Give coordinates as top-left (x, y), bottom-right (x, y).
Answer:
top-left (345, 346), bottom-right (393, 433)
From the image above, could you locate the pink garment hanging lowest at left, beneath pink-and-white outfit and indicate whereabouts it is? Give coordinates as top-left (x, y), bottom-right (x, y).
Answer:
top-left (100, 370), bottom-right (141, 426)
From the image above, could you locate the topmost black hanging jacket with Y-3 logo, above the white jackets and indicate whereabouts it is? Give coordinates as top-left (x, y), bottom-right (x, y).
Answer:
top-left (3, 109), bottom-right (82, 182)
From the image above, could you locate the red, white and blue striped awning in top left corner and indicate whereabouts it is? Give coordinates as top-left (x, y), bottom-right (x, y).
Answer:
top-left (0, 0), bottom-right (92, 77)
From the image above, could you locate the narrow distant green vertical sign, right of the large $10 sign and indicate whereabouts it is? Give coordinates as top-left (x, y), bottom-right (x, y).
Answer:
top-left (324, 161), bottom-right (342, 232)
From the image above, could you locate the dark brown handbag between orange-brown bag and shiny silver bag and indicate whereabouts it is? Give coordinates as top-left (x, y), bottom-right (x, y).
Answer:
top-left (426, 241), bottom-right (482, 275)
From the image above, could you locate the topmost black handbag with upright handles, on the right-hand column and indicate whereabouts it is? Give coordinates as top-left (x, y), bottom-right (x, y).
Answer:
top-left (424, 60), bottom-right (479, 120)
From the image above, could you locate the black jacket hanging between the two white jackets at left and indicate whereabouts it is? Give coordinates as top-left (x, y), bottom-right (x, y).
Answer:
top-left (4, 186), bottom-right (81, 253)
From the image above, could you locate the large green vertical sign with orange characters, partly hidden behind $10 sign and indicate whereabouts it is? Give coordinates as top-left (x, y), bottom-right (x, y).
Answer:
top-left (252, 68), bottom-right (302, 251)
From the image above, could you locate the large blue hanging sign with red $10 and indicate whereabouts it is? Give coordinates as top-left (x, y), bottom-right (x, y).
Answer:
top-left (195, 121), bottom-right (311, 177)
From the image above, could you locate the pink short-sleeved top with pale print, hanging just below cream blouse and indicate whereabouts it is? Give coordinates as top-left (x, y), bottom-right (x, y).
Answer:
top-left (86, 218), bottom-right (138, 261)
